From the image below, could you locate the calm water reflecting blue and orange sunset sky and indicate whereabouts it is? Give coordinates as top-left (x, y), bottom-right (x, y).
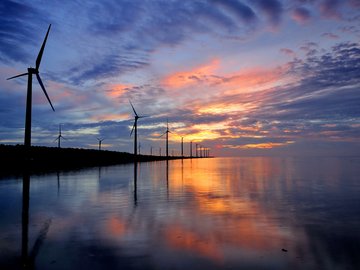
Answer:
top-left (0, 158), bottom-right (360, 270)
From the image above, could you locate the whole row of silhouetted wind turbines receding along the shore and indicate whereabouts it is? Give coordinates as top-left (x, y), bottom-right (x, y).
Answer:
top-left (7, 24), bottom-right (210, 157)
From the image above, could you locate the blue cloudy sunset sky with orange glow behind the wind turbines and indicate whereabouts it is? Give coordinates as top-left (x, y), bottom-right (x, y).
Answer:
top-left (0, 0), bottom-right (360, 156)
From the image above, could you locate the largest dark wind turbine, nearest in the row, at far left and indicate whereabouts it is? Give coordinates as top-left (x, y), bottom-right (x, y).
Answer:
top-left (7, 24), bottom-right (55, 147)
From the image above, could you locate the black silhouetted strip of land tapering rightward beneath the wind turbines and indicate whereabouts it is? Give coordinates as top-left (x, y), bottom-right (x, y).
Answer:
top-left (0, 145), bottom-right (202, 175)
